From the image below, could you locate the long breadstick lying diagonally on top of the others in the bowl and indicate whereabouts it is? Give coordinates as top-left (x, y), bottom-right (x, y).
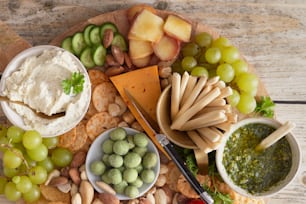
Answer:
top-left (171, 88), bottom-right (220, 130)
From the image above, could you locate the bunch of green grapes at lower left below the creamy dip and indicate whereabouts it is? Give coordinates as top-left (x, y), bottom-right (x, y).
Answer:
top-left (0, 126), bottom-right (72, 202)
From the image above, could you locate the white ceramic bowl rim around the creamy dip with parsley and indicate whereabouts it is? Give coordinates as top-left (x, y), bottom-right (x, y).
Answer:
top-left (0, 45), bottom-right (91, 137)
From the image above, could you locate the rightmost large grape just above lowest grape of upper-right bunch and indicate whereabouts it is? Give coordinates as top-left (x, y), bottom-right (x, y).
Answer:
top-left (235, 72), bottom-right (258, 93)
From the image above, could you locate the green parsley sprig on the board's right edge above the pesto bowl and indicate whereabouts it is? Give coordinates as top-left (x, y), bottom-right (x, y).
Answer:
top-left (255, 96), bottom-right (275, 118)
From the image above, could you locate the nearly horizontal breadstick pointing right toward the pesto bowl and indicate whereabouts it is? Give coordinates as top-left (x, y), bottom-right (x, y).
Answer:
top-left (179, 111), bottom-right (227, 131)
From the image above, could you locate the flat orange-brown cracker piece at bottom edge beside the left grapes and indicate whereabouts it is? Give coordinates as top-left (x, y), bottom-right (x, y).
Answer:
top-left (39, 185), bottom-right (71, 204)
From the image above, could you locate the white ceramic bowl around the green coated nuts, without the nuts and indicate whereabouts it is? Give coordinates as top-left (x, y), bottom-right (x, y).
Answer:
top-left (85, 128), bottom-right (160, 200)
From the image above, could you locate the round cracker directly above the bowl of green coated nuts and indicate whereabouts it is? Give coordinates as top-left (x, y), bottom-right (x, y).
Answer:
top-left (86, 111), bottom-right (119, 140)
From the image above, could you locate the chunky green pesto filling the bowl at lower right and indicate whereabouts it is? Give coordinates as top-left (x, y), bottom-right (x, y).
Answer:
top-left (223, 124), bottom-right (292, 194)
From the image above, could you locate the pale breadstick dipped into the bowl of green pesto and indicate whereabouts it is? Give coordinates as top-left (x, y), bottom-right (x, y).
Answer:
top-left (255, 121), bottom-right (295, 152)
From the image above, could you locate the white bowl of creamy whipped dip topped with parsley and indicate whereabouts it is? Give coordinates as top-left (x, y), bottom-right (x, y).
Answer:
top-left (0, 45), bottom-right (91, 137)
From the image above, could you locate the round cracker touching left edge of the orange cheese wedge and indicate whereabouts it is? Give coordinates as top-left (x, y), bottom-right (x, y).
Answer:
top-left (92, 82), bottom-right (118, 112)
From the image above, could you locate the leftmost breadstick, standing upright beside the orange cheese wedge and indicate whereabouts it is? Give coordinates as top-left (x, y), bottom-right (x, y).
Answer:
top-left (171, 72), bottom-right (181, 119)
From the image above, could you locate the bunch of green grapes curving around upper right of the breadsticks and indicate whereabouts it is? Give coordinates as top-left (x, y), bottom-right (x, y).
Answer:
top-left (172, 32), bottom-right (258, 114)
